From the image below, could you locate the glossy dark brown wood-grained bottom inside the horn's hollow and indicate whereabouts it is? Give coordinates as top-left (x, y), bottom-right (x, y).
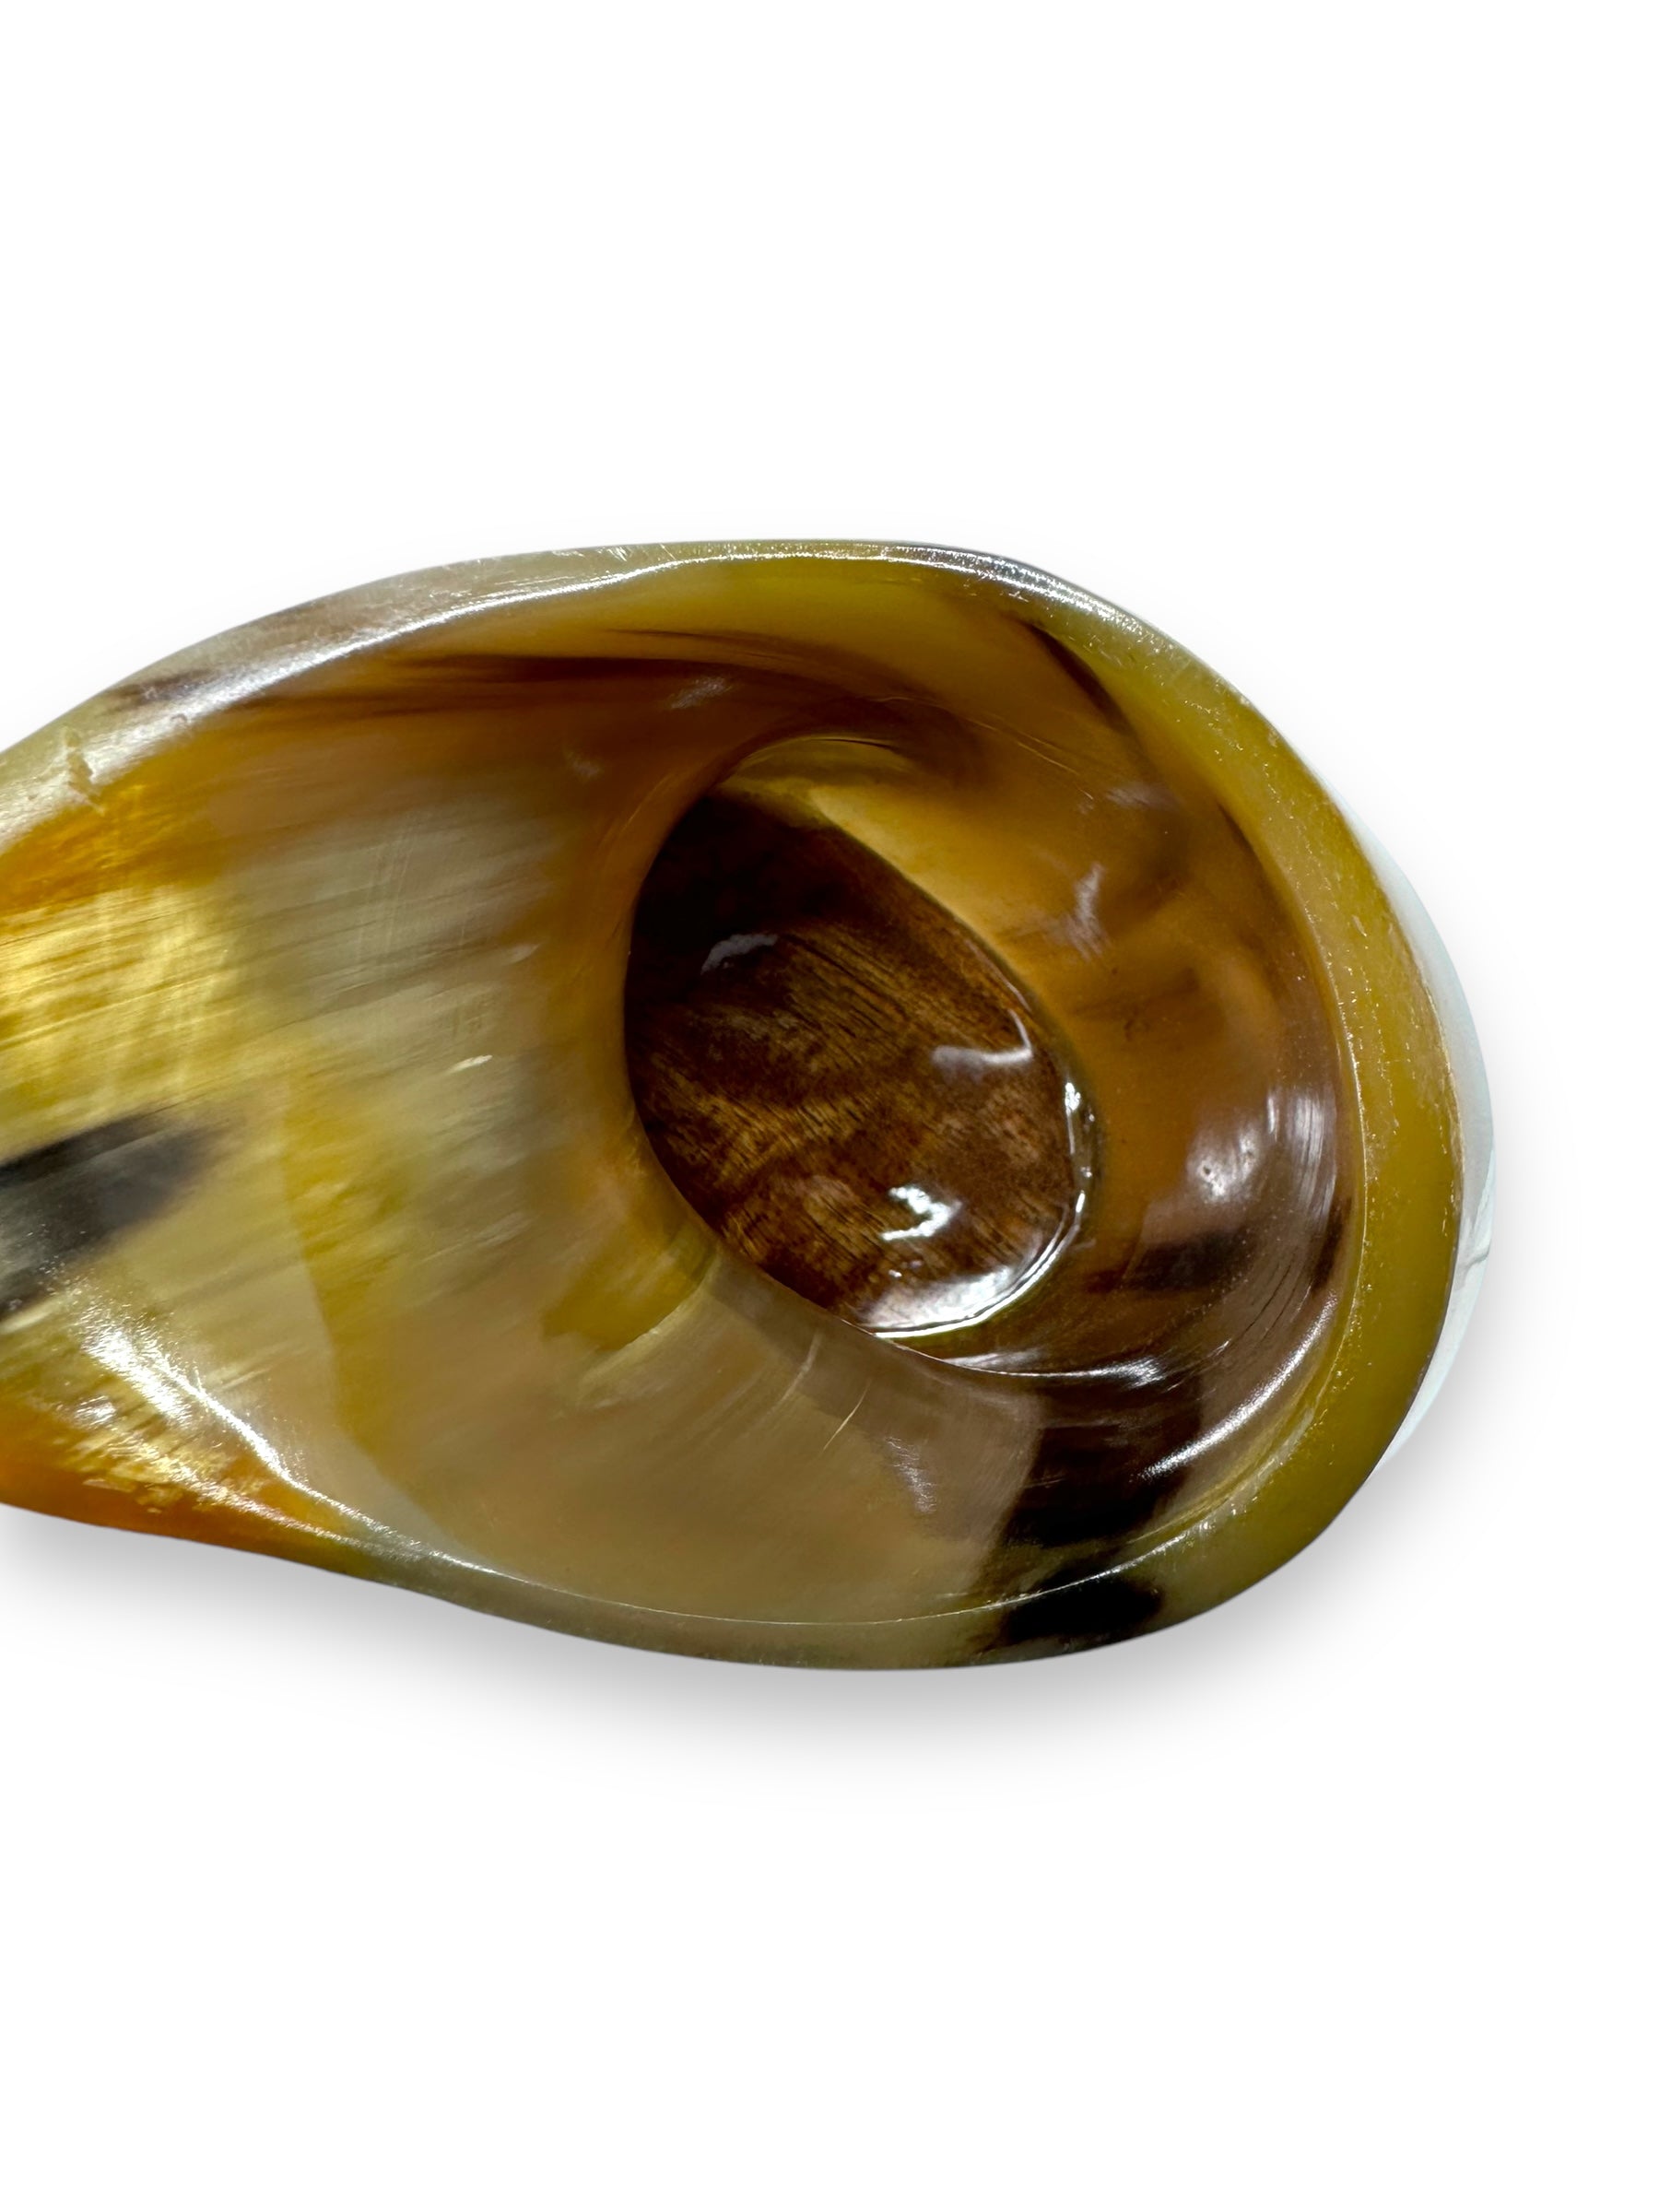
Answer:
top-left (626, 794), bottom-right (1077, 1327)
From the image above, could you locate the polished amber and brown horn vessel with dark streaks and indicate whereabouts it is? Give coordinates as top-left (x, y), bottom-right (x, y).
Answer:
top-left (0, 544), bottom-right (1491, 1665)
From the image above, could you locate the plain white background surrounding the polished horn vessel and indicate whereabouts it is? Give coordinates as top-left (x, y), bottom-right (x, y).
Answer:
top-left (0, 0), bottom-right (1659, 2212)
